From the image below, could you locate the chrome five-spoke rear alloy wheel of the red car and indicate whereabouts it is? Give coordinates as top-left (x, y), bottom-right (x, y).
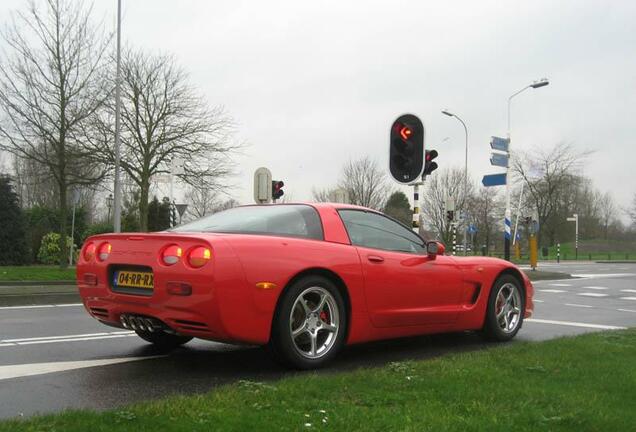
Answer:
top-left (289, 287), bottom-right (340, 359)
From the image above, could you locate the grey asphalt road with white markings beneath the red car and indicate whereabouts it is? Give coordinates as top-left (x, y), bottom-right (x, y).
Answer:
top-left (0, 263), bottom-right (636, 418)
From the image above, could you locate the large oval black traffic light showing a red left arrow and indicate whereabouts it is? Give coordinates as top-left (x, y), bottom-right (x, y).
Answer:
top-left (389, 114), bottom-right (424, 184)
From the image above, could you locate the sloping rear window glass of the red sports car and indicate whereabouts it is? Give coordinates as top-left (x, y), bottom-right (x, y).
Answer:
top-left (170, 204), bottom-right (323, 240)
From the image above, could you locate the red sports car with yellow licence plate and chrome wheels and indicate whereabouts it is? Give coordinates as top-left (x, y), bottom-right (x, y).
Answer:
top-left (77, 204), bottom-right (533, 368)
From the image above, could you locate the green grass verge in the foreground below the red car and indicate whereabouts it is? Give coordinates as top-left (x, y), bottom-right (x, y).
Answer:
top-left (0, 329), bottom-right (636, 432)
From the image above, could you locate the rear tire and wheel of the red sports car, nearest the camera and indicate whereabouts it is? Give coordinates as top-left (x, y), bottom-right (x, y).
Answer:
top-left (269, 276), bottom-right (348, 369)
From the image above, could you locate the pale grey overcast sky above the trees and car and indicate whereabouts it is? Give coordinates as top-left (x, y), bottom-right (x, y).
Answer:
top-left (0, 0), bottom-right (636, 216)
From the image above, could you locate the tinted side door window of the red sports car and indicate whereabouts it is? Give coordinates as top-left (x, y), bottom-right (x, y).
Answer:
top-left (339, 210), bottom-right (426, 253)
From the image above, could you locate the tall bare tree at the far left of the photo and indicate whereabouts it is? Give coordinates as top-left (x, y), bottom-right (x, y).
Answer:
top-left (0, 0), bottom-right (108, 266)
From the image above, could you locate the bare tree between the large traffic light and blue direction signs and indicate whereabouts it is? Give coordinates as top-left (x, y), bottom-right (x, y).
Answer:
top-left (422, 168), bottom-right (473, 243)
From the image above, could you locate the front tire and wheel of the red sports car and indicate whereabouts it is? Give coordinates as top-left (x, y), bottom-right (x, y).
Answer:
top-left (483, 274), bottom-right (526, 342)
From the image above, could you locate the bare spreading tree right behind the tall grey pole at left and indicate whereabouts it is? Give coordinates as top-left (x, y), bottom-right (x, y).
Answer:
top-left (91, 50), bottom-right (239, 231)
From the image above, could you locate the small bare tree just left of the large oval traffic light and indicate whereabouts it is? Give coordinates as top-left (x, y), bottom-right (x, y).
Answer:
top-left (338, 156), bottom-right (392, 210)
